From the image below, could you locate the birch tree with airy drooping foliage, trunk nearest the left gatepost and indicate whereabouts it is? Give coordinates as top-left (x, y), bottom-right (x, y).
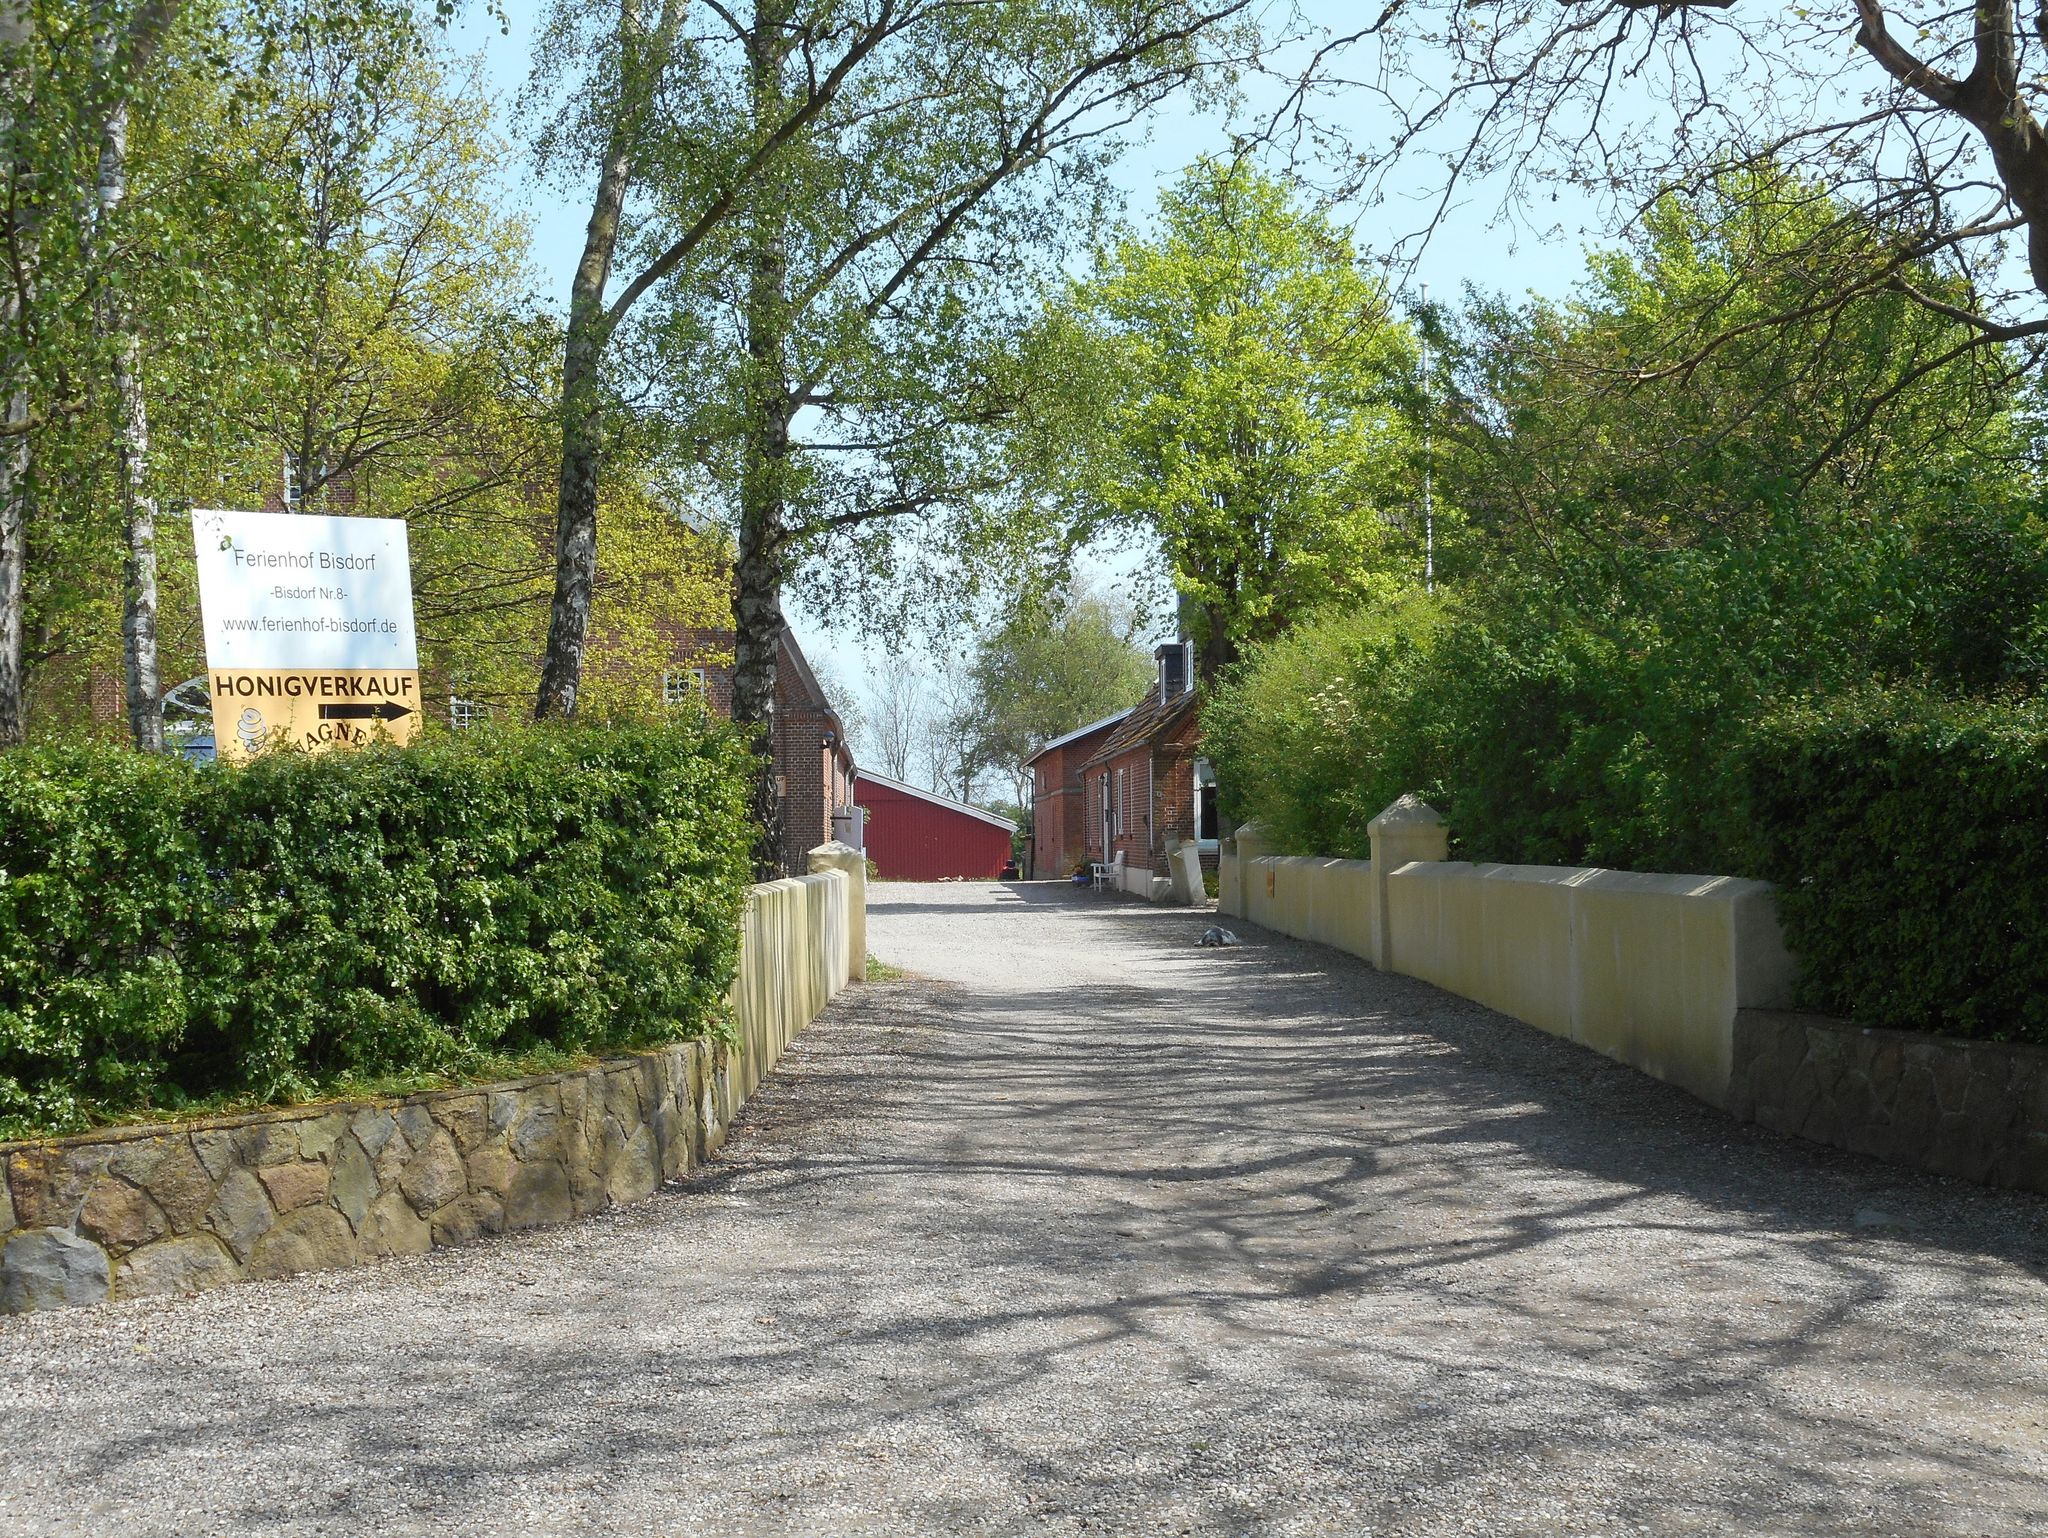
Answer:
top-left (598, 0), bottom-right (1255, 868)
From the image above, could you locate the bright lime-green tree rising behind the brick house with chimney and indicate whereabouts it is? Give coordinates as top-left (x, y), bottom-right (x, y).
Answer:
top-left (1047, 160), bottom-right (1421, 680)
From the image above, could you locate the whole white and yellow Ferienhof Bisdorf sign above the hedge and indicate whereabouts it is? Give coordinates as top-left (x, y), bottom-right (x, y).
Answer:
top-left (193, 510), bottom-right (422, 762)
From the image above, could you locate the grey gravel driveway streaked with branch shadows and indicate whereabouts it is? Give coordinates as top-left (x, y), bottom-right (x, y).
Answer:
top-left (0, 885), bottom-right (2048, 1538)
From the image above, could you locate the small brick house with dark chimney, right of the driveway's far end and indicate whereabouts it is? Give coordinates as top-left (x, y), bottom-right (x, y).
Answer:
top-left (1077, 641), bottom-right (1217, 877)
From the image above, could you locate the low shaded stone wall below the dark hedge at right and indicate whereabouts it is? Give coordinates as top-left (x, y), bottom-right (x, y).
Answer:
top-left (1729, 1010), bottom-right (2048, 1194)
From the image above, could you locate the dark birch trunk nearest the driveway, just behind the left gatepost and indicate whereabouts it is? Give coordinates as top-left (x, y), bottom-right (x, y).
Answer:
top-left (733, 0), bottom-right (791, 881)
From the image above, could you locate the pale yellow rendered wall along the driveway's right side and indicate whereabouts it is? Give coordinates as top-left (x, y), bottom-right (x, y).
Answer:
top-left (1227, 854), bottom-right (1796, 1106)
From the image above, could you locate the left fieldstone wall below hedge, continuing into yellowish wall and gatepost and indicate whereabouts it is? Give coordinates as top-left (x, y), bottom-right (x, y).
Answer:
top-left (0, 860), bottom-right (866, 1313)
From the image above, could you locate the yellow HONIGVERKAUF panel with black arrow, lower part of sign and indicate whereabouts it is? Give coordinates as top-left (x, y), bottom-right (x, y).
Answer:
top-left (207, 668), bottom-right (420, 762)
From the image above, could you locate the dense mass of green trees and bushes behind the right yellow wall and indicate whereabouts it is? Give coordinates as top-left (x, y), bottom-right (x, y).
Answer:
top-left (1208, 176), bottom-right (2048, 870)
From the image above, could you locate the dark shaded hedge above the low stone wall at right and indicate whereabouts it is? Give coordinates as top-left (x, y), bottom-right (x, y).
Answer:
top-left (1739, 694), bottom-right (2048, 1042)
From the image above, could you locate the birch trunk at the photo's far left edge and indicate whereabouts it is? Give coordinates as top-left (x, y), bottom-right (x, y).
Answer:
top-left (0, 0), bottom-right (37, 747)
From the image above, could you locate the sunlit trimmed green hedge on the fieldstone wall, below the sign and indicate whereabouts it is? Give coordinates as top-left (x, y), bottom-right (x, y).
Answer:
top-left (0, 719), bottom-right (752, 1137)
